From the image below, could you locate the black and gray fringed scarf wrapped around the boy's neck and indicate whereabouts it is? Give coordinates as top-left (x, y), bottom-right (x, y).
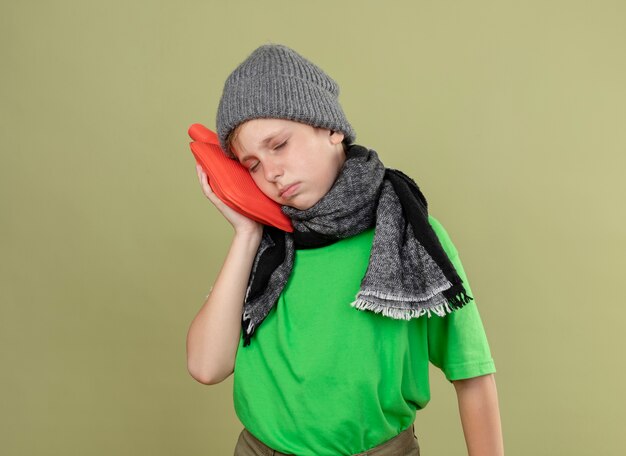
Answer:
top-left (241, 144), bottom-right (473, 347)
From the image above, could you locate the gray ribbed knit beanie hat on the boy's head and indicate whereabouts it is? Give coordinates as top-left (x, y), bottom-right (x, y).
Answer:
top-left (216, 44), bottom-right (356, 159)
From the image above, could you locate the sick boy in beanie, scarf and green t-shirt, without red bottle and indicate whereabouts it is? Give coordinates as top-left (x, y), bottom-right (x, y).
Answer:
top-left (187, 44), bottom-right (503, 456)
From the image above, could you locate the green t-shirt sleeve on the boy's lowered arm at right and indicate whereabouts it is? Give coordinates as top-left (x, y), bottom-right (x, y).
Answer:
top-left (427, 215), bottom-right (496, 381)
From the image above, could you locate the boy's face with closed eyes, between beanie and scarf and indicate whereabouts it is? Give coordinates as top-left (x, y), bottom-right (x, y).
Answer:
top-left (232, 118), bottom-right (346, 210)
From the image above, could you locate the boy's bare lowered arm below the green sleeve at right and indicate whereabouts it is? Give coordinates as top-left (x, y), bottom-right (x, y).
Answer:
top-left (452, 374), bottom-right (504, 456)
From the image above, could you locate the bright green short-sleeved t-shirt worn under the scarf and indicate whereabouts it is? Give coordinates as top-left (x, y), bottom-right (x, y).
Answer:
top-left (233, 215), bottom-right (496, 456)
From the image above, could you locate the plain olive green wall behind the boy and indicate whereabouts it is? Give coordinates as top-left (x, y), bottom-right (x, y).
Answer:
top-left (0, 0), bottom-right (626, 456)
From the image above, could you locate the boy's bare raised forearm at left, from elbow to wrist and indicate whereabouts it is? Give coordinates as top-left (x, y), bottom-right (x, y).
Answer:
top-left (187, 230), bottom-right (263, 385)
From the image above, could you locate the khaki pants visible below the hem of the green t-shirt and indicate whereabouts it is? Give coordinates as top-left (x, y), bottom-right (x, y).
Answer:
top-left (234, 424), bottom-right (420, 456)
